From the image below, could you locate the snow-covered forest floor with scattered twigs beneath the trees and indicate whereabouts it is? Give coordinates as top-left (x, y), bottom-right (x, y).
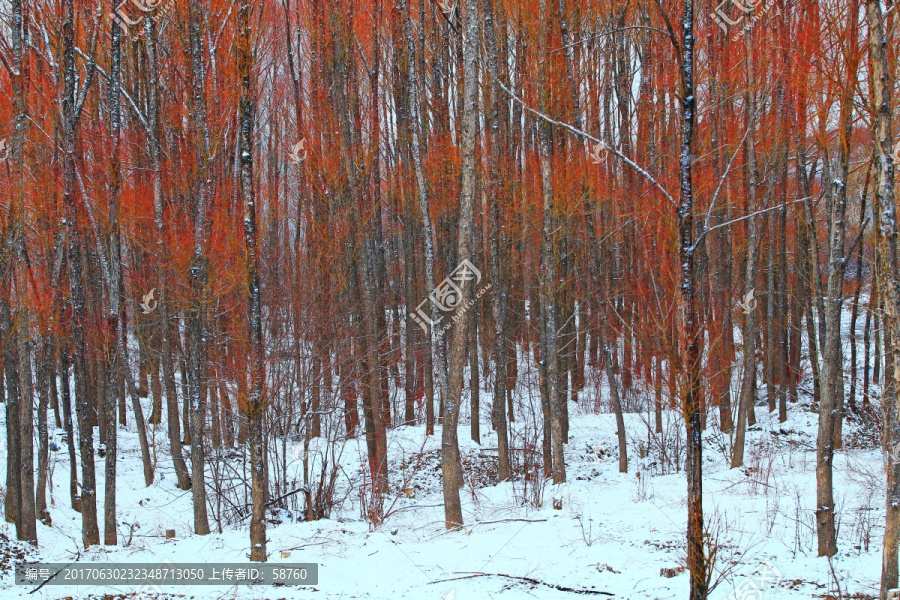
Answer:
top-left (0, 364), bottom-right (885, 600)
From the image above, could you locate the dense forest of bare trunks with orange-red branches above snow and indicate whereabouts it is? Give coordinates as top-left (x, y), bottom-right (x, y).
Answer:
top-left (0, 0), bottom-right (900, 600)
